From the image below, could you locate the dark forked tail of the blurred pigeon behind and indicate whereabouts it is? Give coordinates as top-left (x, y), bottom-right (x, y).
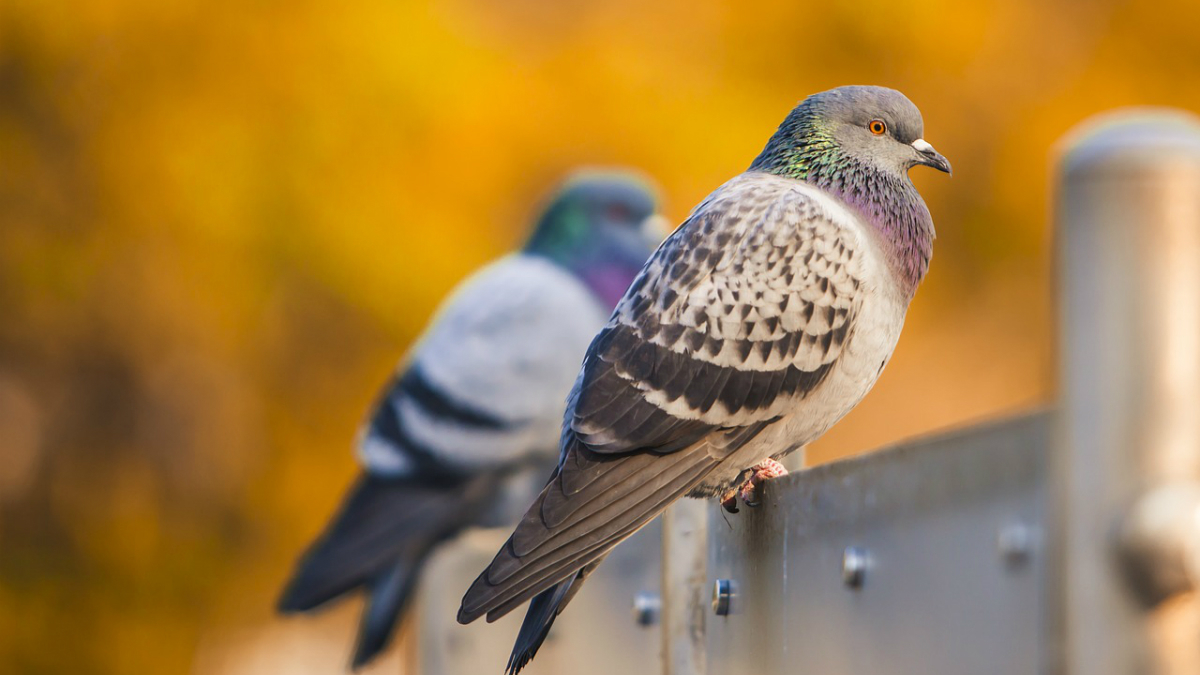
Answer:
top-left (278, 474), bottom-right (500, 668)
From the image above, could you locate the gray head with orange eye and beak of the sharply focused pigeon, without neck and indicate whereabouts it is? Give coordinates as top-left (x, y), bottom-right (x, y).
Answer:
top-left (750, 86), bottom-right (950, 179)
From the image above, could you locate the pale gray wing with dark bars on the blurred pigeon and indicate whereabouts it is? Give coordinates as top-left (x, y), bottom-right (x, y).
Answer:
top-left (359, 255), bottom-right (606, 477)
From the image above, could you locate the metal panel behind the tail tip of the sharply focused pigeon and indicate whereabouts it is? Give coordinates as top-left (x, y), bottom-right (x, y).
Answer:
top-left (416, 511), bottom-right (662, 675)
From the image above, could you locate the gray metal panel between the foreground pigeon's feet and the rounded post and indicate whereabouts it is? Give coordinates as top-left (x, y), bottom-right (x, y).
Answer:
top-left (707, 413), bottom-right (1050, 675)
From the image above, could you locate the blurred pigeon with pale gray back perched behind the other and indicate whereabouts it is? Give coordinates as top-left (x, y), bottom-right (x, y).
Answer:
top-left (278, 171), bottom-right (666, 668)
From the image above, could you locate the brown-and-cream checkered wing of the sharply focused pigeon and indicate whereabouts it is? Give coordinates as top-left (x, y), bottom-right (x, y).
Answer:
top-left (458, 174), bottom-right (865, 622)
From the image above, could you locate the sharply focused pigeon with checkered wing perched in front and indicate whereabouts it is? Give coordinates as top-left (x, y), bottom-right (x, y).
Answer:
top-left (458, 86), bottom-right (950, 675)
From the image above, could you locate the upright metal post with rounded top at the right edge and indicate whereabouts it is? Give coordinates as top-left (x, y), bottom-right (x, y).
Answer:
top-left (1046, 110), bottom-right (1200, 675)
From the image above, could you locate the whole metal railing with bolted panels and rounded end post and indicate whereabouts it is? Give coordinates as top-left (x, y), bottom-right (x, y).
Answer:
top-left (419, 110), bottom-right (1200, 675)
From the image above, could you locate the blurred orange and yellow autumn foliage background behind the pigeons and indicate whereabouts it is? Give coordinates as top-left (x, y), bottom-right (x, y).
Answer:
top-left (0, 0), bottom-right (1200, 674)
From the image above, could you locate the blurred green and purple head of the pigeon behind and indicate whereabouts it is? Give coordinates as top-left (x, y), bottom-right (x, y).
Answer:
top-left (524, 169), bottom-right (667, 307)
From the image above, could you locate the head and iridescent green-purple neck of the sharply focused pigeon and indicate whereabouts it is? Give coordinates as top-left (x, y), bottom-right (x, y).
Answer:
top-left (750, 86), bottom-right (950, 293)
